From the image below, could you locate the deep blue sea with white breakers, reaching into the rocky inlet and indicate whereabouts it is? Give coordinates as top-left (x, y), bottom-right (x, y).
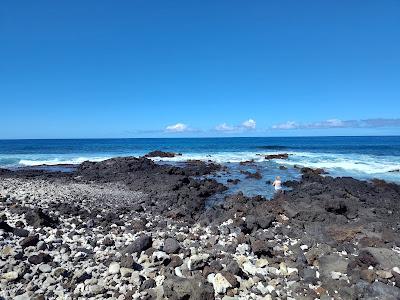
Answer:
top-left (0, 136), bottom-right (400, 196)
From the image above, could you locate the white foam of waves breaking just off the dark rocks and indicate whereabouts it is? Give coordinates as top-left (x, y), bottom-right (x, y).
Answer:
top-left (13, 151), bottom-right (400, 181)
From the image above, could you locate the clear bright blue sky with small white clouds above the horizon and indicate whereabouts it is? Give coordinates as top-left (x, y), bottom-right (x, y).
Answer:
top-left (0, 0), bottom-right (400, 138)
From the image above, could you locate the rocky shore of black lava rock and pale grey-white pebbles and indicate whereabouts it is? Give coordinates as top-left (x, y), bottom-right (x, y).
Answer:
top-left (0, 153), bottom-right (400, 300)
